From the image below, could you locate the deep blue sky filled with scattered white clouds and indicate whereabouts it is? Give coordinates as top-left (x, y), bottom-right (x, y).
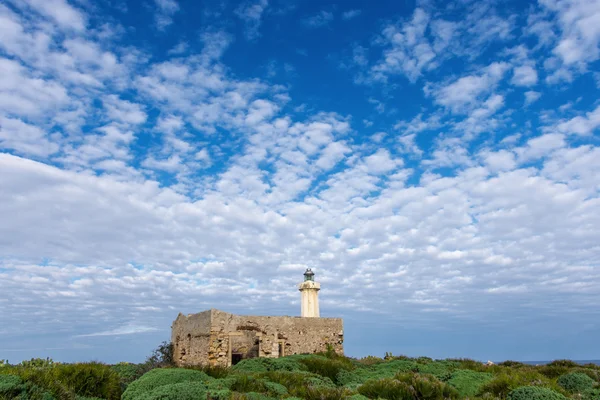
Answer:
top-left (0, 0), bottom-right (600, 362)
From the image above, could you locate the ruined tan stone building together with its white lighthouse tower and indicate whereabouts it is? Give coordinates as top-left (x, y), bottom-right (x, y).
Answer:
top-left (171, 268), bottom-right (344, 366)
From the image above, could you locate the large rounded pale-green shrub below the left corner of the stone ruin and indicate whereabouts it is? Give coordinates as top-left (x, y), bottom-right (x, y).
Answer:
top-left (122, 368), bottom-right (213, 400)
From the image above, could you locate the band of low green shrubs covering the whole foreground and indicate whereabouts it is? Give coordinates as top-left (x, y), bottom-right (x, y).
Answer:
top-left (0, 343), bottom-right (600, 400)
